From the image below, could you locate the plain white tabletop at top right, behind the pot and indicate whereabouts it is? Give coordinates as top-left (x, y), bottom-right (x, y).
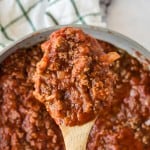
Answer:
top-left (107, 0), bottom-right (150, 51)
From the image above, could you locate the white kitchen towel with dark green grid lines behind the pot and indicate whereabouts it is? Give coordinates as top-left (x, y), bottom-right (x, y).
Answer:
top-left (0, 0), bottom-right (106, 49)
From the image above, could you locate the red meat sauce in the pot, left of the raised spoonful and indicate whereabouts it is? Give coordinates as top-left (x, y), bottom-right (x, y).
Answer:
top-left (0, 45), bottom-right (64, 150)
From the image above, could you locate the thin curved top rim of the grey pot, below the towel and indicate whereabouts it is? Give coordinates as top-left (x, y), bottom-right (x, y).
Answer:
top-left (0, 24), bottom-right (150, 59)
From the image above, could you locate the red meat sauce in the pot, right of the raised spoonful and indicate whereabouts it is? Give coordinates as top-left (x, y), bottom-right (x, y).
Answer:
top-left (87, 42), bottom-right (150, 150)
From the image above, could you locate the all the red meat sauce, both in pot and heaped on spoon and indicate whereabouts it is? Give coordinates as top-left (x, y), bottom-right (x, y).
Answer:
top-left (0, 27), bottom-right (150, 150)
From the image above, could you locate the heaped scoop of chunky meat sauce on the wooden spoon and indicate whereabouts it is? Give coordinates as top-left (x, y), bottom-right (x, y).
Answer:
top-left (34, 27), bottom-right (119, 126)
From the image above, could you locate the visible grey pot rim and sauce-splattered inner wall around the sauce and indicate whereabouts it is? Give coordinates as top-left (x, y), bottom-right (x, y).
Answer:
top-left (0, 25), bottom-right (150, 67)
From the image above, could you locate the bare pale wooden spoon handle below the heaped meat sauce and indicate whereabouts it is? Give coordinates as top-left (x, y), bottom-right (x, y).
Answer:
top-left (60, 119), bottom-right (95, 150)
